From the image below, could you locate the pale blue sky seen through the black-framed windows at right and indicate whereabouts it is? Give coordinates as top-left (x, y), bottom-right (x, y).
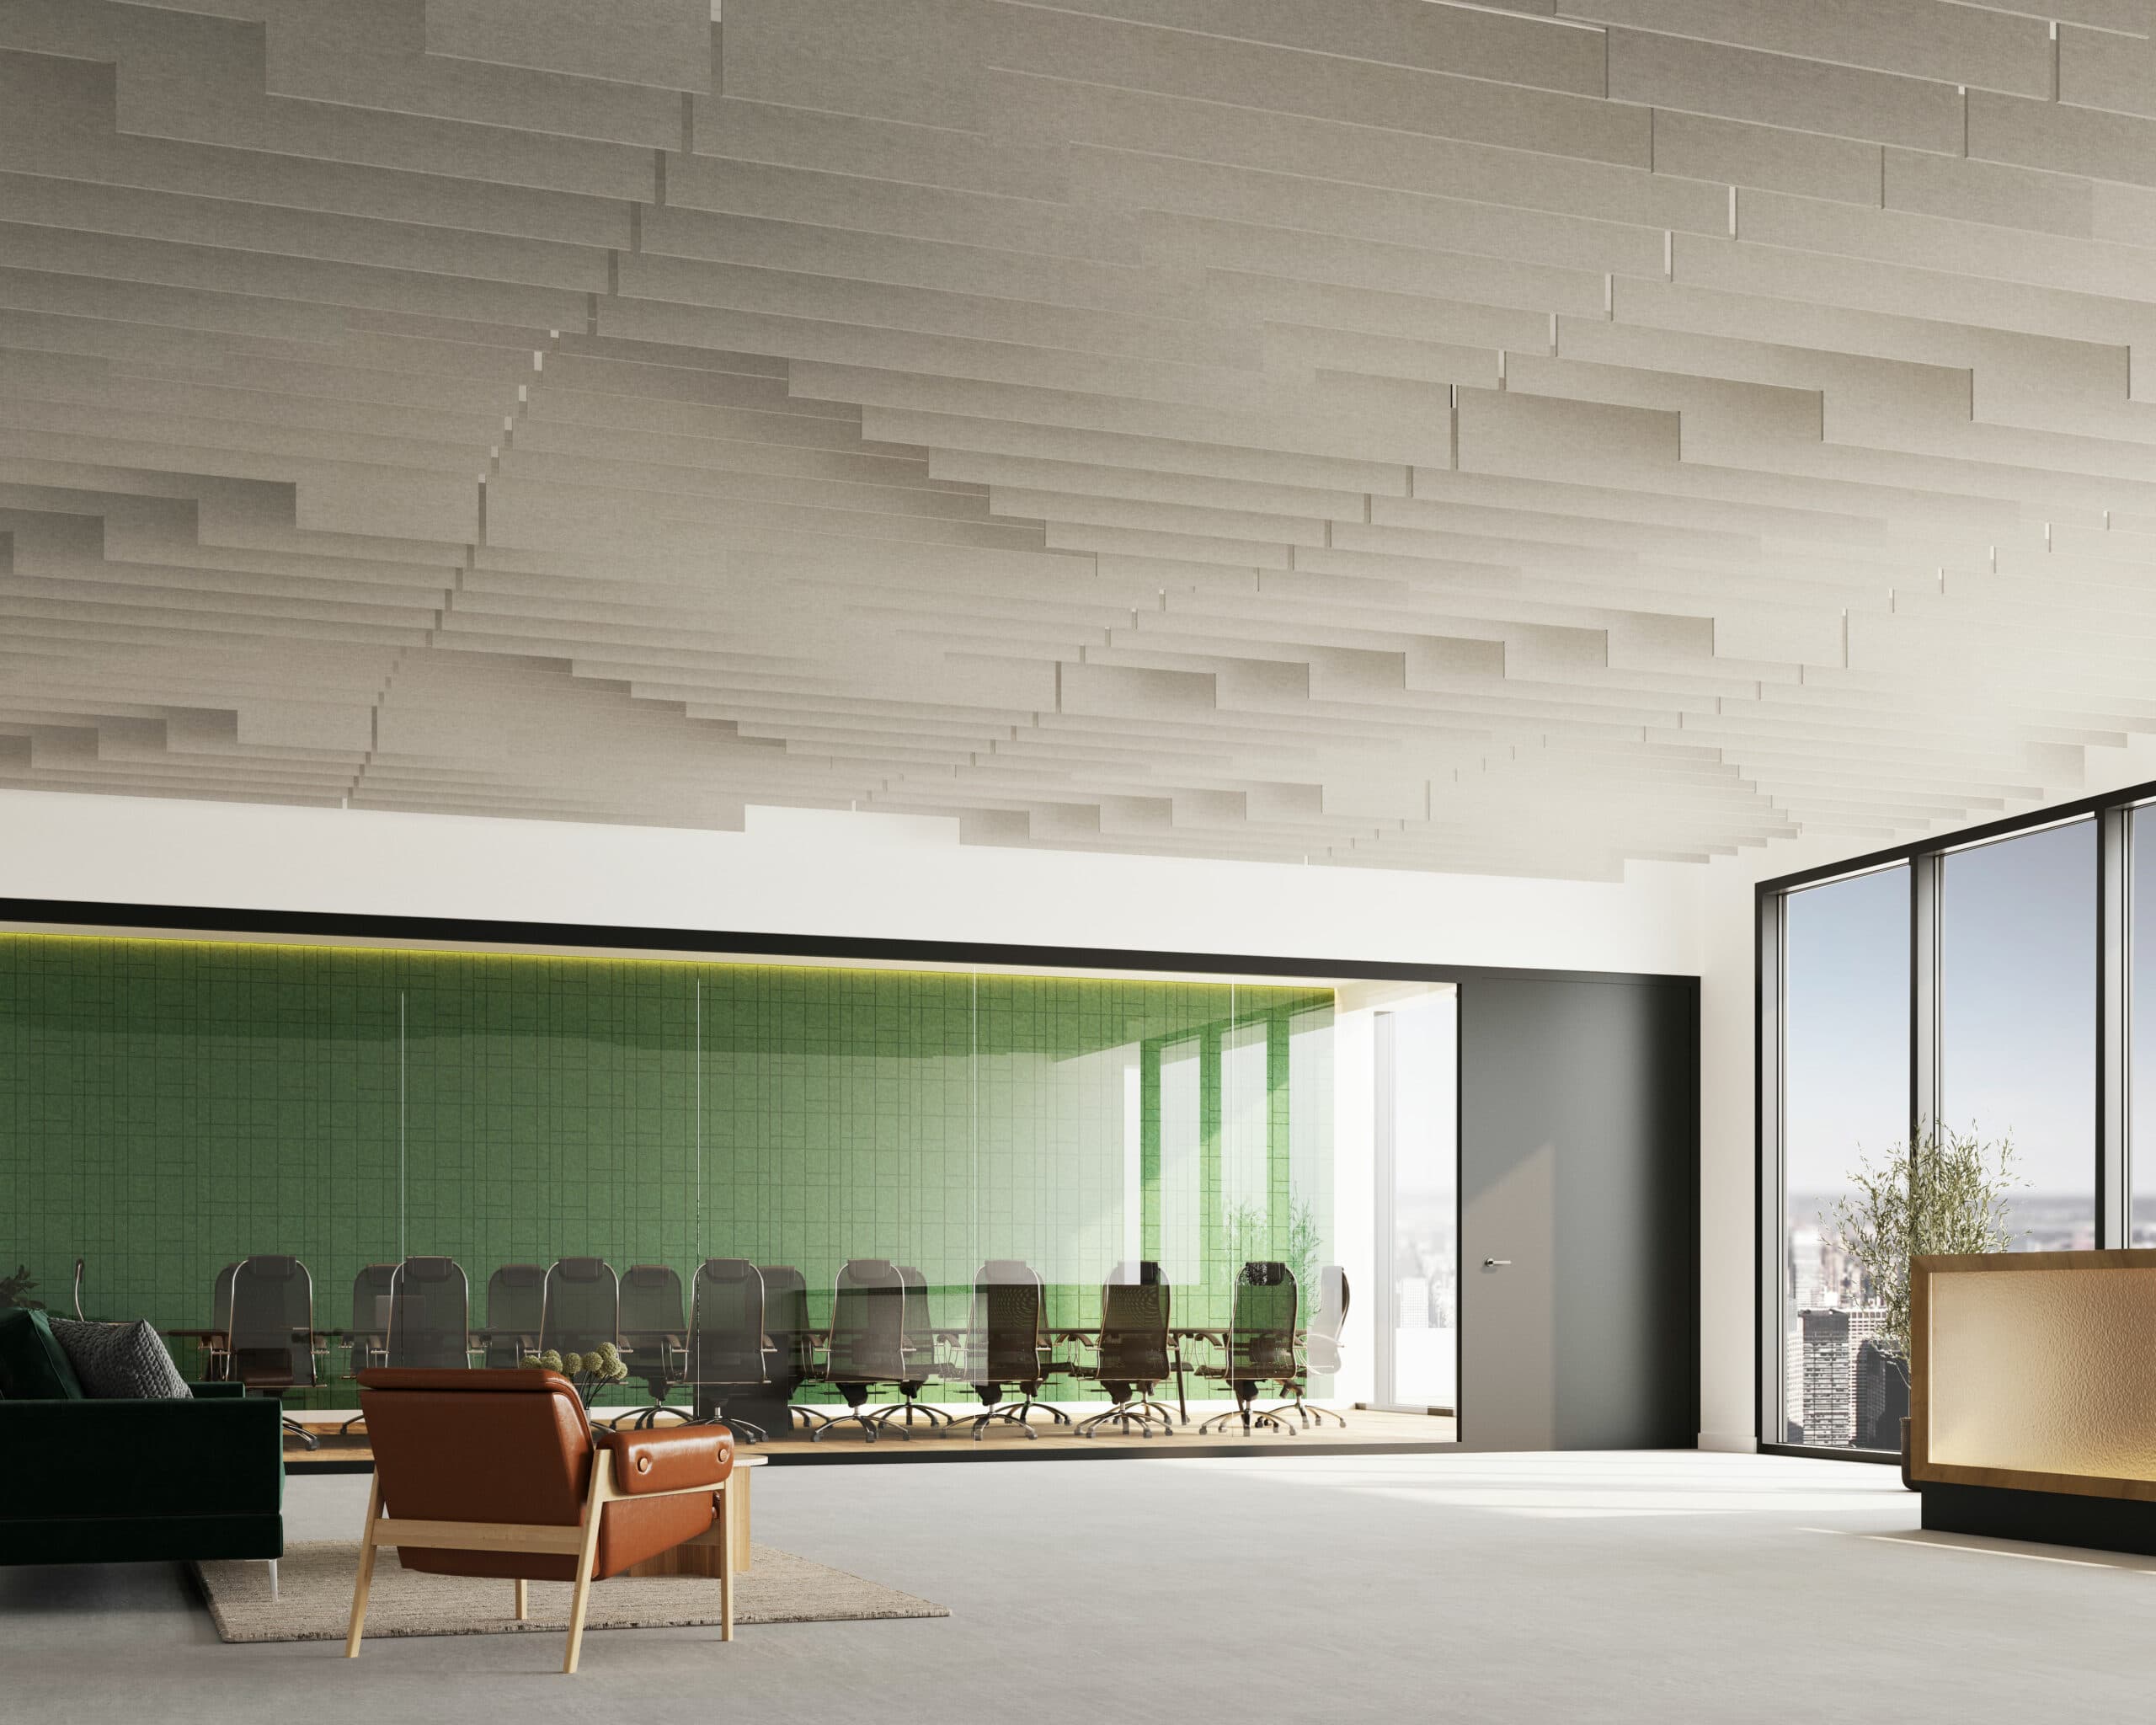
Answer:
top-left (1785, 821), bottom-right (2104, 1197)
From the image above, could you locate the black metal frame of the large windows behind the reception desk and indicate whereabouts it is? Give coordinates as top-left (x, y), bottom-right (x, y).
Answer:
top-left (1755, 782), bottom-right (2156, 1460)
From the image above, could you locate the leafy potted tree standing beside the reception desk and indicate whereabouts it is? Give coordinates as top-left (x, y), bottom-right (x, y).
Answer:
top-left (1822, 1124), bottom-right (2022, 1482)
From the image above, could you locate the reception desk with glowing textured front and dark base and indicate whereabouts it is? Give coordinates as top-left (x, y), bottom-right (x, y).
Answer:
top-left (1908, 1251), bottom-right (2156, 1555)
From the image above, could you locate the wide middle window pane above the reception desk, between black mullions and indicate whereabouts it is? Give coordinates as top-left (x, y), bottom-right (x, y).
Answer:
top-left (1938, 820), bottom-right (2098, 1251)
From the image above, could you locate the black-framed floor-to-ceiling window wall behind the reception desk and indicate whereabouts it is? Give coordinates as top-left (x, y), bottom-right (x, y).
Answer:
top-left (1757, 785), bottom-right (2156, 1453)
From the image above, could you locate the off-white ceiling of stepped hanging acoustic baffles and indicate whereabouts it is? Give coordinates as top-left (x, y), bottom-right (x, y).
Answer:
top-left (0, 0), bottom-right (2156, 875)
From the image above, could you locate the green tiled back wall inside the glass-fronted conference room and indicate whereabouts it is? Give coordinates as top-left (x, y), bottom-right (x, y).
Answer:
top-left (0, 936), bottom-right (1332, 1404)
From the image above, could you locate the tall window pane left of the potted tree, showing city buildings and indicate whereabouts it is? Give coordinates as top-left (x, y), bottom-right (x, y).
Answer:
top-left (1779, 865), bottom-right (1910, 1449)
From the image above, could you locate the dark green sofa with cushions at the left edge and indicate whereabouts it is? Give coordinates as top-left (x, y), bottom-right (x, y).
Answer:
top-left (0, 1311), bottom-right (285, 1563)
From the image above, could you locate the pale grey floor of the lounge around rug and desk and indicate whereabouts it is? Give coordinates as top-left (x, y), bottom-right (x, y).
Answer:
top-left (0, 1440), bottom-right (2156, 1725)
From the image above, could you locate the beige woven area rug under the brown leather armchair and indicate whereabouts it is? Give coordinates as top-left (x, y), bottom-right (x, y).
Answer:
top-left (189, 1540), bottom-right (951, 1641)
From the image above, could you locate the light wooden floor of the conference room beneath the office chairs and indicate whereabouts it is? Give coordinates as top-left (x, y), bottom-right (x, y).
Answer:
top-left (285, 1402), bottom-right (1458, 1472)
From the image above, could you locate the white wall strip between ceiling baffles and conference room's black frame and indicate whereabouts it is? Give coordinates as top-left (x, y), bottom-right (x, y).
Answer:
top-left (0, 792), bottom-right (1699, 973)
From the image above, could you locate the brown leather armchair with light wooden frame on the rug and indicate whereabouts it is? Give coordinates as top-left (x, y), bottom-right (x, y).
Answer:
top-left (345, 1370), bottom-right (733, 1674)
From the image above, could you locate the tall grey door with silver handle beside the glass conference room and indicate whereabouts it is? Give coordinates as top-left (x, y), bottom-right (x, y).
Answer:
top-left (1460, 977), bottom-right (1699, 1449)
